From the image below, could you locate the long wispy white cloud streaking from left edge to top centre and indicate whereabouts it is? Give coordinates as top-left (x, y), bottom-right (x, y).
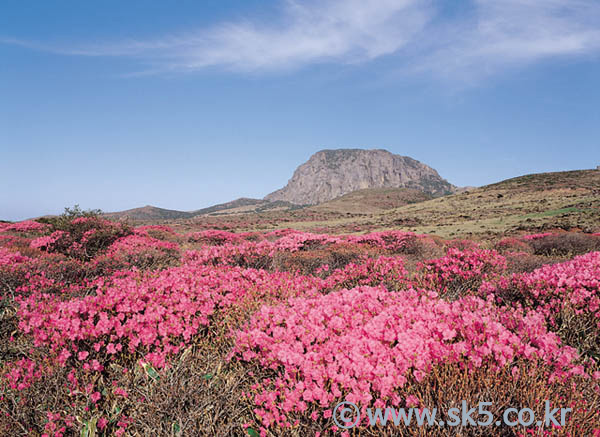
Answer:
top-left (0, 0), bottom-right (433, 72)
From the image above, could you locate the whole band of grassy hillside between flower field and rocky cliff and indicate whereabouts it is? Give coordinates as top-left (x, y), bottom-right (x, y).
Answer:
top-left (105, 170), bottom-right (600, 238)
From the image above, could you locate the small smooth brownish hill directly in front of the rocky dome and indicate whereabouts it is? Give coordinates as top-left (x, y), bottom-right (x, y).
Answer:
top-left (310, 188), bottom-right (433, 214)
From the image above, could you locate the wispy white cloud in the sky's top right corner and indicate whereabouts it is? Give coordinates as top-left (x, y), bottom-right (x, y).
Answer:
top-left (416, 0), bottom-right (600, 76)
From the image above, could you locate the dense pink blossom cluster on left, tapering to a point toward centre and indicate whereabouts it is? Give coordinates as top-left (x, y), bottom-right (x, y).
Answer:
top-left (18, 263), bottom-right (320, 370)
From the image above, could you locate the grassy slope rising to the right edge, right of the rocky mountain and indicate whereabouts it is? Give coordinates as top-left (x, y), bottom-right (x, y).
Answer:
top-left (372, 170), bottom-right (600, 236)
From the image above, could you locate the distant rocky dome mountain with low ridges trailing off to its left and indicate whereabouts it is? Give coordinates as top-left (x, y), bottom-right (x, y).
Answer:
top-left (104, 149), bottom-right (458, 222)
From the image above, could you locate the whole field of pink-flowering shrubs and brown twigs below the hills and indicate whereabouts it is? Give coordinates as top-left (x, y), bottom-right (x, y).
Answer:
top-left (0, 215), bottom-right (600, 437)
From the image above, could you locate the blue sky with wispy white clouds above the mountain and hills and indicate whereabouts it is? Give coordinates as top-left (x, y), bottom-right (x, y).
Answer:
top-left (0, 0), bottom-right (600, 220)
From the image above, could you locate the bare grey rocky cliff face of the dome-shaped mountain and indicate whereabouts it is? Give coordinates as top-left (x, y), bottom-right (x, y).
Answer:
top-left (265, 149), bottom-right (456, 205)
